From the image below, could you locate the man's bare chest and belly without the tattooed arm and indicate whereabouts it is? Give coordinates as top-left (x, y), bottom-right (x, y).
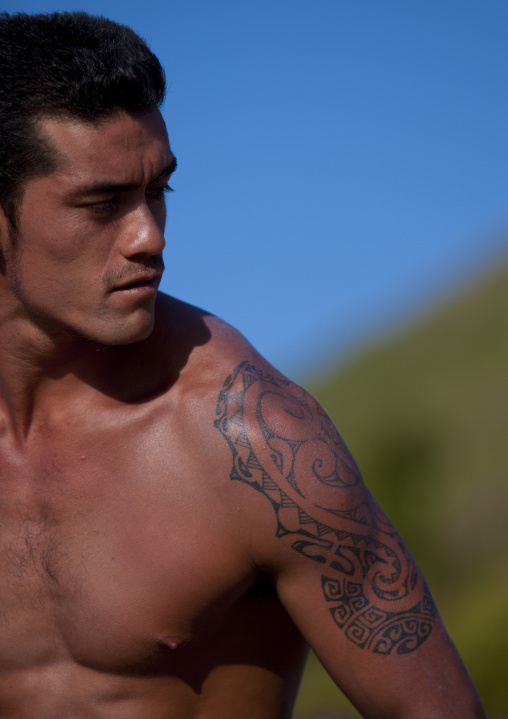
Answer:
top-left (0, 296), bottom-right (305, 719)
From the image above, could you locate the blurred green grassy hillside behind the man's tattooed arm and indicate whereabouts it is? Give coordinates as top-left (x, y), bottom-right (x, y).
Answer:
top-left (295, 263), bottom-right (508, 719)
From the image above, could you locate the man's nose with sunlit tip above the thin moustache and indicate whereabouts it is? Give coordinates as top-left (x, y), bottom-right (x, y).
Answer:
top-left (119, 203), bottom-right (166, 259)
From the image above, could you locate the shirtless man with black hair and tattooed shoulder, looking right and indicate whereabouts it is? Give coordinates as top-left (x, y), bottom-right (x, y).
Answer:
top-left (0, 14), bottom-right (484, 719)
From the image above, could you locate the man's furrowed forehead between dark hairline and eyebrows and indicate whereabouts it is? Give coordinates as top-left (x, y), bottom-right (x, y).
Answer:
top-left (38, 110), bottom-right (173, 183)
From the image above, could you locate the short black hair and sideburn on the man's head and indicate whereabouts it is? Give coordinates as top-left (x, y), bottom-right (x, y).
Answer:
top-left (0, 12), bottom-right (165, 231)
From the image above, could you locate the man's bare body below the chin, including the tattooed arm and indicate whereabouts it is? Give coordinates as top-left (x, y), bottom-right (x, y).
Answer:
top-left (0, 298), bottom-right (485, 719)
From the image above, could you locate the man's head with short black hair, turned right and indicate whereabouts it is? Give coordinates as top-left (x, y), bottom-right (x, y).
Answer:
top-left (0, 13), bottom-right (175, 345)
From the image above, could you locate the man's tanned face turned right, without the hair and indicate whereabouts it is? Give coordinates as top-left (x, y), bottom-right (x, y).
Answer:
top-left (2, 110), bottom-right (176, 345)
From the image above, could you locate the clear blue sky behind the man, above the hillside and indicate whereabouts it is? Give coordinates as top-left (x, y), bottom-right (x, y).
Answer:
top-left (6, 0), bottom-right (508, 378)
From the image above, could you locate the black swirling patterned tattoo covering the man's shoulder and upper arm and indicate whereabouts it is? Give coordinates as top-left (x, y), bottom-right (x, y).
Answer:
top-left (215, 362), bottom-right (435, 654)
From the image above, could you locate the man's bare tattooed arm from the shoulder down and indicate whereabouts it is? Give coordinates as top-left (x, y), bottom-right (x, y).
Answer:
top-left (216, 362), bottom-right (482, 717)
